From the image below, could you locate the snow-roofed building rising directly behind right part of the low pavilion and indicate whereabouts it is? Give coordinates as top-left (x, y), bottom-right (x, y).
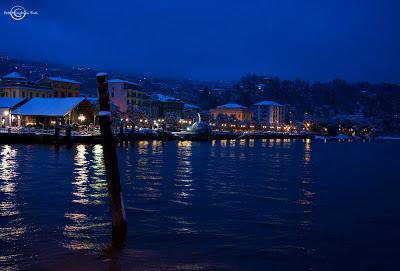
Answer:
top-left (39, 75), bottom-right (81, 98)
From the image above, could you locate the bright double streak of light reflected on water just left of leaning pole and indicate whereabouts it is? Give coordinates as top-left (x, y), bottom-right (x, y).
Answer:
top-left (63, 145), bottom-right (110, 251)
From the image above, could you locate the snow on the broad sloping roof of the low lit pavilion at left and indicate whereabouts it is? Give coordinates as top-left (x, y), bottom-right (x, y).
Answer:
top-left (13, 97), bottom-right (85, 117)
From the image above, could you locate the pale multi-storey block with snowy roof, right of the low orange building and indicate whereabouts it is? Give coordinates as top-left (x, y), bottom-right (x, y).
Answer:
top-left (252, 101), bottom-right (285, 125)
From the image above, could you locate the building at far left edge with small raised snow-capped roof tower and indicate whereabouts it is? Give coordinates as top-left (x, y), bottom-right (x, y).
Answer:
top-left (0, 72), bottom-right (53, 99)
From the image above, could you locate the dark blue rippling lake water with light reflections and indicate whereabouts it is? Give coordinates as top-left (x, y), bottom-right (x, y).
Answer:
top-left (0, 140), bottom-right (400, 270)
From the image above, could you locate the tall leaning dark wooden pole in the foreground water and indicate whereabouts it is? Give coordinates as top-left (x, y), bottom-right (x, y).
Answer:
top-left (97, 73), bottom-right (127, 241)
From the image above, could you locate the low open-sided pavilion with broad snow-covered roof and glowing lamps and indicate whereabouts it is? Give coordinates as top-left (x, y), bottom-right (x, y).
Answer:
top-left (13, 97), bottom-right (96, 128)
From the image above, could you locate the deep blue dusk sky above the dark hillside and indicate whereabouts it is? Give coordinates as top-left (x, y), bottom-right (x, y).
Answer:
top-left (0, 0), bottom-right (400, 83)
